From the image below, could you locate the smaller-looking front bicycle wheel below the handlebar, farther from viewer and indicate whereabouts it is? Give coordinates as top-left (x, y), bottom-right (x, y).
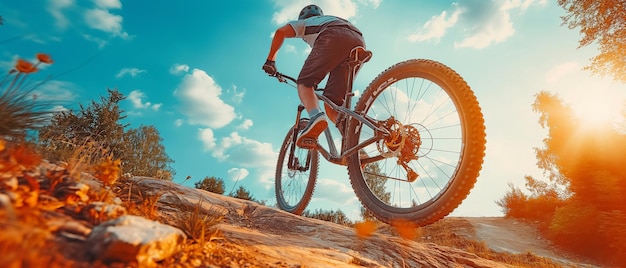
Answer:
top-left (274, 120), bottom-right (319, 215)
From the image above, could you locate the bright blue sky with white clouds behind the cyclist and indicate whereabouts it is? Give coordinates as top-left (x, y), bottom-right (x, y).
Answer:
top-left (0, 0), bottom-right (626, 219)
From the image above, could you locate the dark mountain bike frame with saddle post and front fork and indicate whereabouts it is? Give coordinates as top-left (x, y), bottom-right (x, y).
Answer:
top-left (275, 48), bottom-right (389, 168)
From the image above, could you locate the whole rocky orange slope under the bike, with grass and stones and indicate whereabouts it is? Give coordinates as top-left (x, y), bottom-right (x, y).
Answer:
top-left (0, 156), bottom-right (604, 268)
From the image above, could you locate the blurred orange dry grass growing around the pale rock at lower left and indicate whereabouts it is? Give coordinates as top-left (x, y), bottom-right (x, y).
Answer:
top-left (0, 138), bottom-right (227, 268)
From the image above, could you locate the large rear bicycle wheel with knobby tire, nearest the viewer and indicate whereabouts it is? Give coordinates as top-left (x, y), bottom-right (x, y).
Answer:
top-left (348, 60), bottom-right (485, 226)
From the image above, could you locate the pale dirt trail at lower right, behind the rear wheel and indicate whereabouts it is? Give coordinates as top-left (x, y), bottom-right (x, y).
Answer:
top-left (462, 217), bottom-right (600, 267)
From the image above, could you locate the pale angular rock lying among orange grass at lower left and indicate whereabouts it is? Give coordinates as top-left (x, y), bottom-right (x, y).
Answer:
top-left (87, 215), bottom-right (186, 267)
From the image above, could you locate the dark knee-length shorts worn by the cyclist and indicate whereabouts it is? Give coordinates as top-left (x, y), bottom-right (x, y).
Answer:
top-left (298, 27), bottom-right (365, 105)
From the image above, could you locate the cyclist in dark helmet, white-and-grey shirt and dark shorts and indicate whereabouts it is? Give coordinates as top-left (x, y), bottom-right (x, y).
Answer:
top-left (263, 5), bottom-right (365, 148)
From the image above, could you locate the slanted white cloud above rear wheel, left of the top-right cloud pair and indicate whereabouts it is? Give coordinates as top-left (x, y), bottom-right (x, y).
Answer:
top-left (407, 5), bottom-right (462, 42)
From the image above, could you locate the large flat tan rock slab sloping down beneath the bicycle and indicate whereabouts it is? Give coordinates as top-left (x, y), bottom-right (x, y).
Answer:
top-left (133, 177), bottom-right (511, 268)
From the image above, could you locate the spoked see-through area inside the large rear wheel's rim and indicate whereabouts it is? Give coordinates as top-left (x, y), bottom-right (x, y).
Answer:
top-left (360, 75), bottom-right (462, 207)
